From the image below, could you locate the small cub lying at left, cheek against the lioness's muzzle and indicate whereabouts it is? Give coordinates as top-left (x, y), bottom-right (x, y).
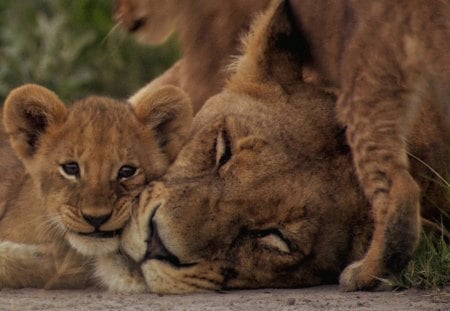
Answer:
top-left (0, 85), bottom-right (192, 288)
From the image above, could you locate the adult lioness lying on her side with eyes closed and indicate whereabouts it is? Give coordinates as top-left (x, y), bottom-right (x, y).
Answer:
top-left (110, 3), bottom-right (450, 293)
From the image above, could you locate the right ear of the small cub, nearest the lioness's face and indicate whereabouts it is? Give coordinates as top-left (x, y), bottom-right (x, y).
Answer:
top-left (133, 86), bottom-right (193, 162)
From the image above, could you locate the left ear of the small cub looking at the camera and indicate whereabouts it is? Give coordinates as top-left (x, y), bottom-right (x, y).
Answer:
top-left (3, 84), bottom-right (67, 160)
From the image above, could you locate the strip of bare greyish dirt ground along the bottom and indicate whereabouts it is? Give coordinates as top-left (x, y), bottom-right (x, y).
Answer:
top-left (0, 286), bottom-right (450, 311)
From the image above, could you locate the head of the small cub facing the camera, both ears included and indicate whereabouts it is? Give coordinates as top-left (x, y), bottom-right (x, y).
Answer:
top-left (3, 85), bottom-right (192, 255)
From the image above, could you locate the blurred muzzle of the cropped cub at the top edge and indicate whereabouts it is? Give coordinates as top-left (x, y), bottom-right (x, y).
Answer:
top-left (114, 0), bottom-right (183, 45)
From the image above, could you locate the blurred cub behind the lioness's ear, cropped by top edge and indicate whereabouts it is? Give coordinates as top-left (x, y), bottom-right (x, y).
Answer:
top-left (115, 0), bottom-right (269, 113)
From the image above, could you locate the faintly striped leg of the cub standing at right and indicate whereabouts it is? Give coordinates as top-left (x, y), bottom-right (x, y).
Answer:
top-left (338, 78), bottom-right (420, 290)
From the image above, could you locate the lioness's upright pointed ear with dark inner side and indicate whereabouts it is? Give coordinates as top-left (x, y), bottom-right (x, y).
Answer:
top-left (232, 0), bottom-right (311, 83)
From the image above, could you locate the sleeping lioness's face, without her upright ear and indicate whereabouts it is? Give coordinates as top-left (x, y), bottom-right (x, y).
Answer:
top-left (123, 90), bottom-right (371, 293)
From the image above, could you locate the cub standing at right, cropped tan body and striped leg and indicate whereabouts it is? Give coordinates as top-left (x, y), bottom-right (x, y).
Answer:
top-left (290, 0), bottom-right (450, 290)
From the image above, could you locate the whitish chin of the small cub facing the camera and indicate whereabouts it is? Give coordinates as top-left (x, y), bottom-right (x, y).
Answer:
top-left (66, 232), bottom-right (120, 256)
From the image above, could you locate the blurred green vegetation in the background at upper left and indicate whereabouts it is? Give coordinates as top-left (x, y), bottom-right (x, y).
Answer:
top-left (0, 0), bottom-right (179, 104)
